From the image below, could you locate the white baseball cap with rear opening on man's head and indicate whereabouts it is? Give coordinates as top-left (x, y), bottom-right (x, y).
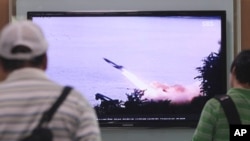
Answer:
top-left (0, 20), bottom-right (48, 60)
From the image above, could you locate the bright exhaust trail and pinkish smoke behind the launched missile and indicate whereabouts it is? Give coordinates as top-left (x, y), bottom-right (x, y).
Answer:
top-left (122, 69), bottom-right (200, 104)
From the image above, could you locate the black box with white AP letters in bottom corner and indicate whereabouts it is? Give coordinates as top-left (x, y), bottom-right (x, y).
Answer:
top-left (230, 125), bottom-right (250, 141)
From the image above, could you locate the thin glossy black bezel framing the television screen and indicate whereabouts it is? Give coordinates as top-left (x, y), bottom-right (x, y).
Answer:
top-left (27, 10), bottom-right (227, 128)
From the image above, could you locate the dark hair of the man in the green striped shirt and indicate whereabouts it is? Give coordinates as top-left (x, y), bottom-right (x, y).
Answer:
top-left (230, 50), bottom-right (250, 84)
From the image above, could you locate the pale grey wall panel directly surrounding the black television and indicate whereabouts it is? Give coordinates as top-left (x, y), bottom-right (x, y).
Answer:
top-left (16, 0), bottom-right (234, 141)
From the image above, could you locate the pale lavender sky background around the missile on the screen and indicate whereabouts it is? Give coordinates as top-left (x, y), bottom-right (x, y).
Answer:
top-left (33, 17), bottom-right (221, 104)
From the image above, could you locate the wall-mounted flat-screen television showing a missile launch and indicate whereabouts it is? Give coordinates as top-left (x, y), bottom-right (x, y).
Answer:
top-left (27, 11), bottom-right (227, 127)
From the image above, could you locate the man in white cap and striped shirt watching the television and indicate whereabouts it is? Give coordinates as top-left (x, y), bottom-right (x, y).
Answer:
top-left (0, 21), bottom-right (101, 141)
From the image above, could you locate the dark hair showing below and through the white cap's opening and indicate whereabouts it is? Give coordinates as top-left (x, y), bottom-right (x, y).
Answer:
top-left (0, 45), bottom-right (46, 72)
